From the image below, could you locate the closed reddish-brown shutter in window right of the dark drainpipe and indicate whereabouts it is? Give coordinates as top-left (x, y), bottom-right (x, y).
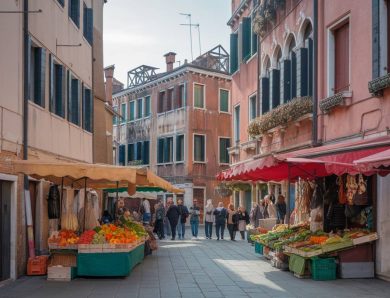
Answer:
top-left (334, 23), bottom-right (349, 93)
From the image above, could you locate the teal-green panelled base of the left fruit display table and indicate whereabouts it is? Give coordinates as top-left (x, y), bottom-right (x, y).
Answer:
top-left (77, 244), bottom-right (145, 277)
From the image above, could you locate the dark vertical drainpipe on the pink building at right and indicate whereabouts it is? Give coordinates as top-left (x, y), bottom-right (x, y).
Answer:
top-left (312, 0), bottom-right (319, 147)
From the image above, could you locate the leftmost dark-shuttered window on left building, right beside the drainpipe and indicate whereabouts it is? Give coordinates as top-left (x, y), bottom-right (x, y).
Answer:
top-left (29, 41), bottom-right (46, 108)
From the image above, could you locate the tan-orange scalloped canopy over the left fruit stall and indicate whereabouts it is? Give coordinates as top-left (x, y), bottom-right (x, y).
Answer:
top-left (12, 160), bottom-right (183, 195)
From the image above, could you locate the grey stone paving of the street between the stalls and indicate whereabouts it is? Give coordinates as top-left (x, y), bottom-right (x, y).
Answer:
top-left (0, 227), bottom-right (390, 298)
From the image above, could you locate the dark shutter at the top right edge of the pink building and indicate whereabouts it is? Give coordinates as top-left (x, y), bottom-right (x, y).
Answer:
top-left (372, 0), bottom-right (380, 79)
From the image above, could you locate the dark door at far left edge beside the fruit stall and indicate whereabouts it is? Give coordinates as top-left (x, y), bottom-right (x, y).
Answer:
top-left (0, 181), bottom-right (12, 281)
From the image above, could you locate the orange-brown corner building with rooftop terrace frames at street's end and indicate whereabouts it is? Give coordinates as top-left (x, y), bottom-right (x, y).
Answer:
top-left (113, 46), bottom-right (231, 219)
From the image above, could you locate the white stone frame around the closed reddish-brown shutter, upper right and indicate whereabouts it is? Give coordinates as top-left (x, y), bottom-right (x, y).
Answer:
top-left (327, 14), bottom-right (351, 97)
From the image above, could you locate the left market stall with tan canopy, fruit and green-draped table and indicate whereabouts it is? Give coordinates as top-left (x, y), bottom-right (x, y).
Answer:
top-left (13, 160), bottom-right (182, 280)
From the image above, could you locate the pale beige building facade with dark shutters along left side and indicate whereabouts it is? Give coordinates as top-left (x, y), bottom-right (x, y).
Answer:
top-left (0, 0), bottom-right (104, 281)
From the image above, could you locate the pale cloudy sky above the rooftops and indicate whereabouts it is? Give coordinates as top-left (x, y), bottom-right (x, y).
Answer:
top-left (103, 0), bottom-right (231, 86)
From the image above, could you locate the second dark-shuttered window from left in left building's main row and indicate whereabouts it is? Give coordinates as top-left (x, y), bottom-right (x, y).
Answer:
top-left (49, 55), bottom-right (66, 117)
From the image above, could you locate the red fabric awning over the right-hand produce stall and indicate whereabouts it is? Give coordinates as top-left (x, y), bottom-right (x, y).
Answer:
top-left (217, 136), bottom-right (390, 181)
